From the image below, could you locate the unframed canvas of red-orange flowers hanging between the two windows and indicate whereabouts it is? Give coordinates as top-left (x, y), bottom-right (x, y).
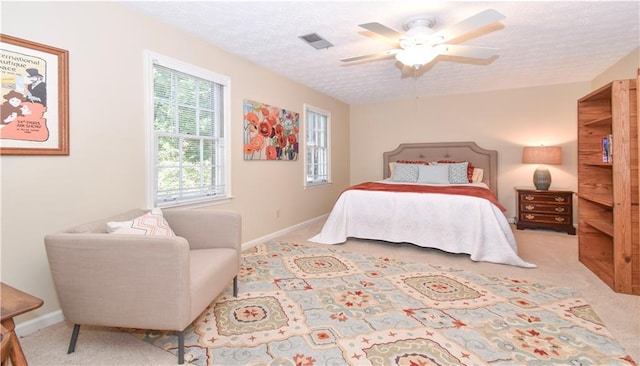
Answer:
top-left (243, 100), bottom-right (300, 160)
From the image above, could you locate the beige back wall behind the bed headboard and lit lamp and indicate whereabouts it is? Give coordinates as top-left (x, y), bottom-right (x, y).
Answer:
top-left (350, 82), bottom-right (589, 218)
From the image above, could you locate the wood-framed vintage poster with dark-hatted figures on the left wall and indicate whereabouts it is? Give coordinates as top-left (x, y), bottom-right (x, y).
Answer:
top-left (0, 34), bottom-right (69, 155)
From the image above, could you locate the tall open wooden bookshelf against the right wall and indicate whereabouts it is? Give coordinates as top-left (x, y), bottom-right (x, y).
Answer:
top-left (578, 70), bottom-right (640, 295)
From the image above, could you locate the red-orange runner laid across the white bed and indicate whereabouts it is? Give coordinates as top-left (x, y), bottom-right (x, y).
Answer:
top-left (345, 182), bottom-right (507, 212)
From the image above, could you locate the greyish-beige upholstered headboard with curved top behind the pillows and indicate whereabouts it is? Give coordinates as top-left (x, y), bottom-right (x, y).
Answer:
top-left (382, 141), bottom-right (498, 197)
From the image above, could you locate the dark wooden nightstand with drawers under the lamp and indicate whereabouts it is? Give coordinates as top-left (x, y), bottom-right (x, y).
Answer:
top-left (515, 187), bottom-right (576, 235)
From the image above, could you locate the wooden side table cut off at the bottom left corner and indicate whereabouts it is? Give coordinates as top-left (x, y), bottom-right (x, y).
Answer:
top-left (0, 282), bottom-right (43, 366)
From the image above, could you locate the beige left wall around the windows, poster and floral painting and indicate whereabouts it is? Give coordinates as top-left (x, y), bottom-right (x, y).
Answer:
top-left (0, 2), bottom-right (349, 321)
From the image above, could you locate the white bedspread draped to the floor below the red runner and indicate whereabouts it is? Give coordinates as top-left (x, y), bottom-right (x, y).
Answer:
top-left (309, 182), bottom-right (536, 268)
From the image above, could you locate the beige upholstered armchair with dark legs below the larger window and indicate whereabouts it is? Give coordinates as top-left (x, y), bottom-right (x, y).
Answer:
top-left (45, 210), bottom-right (241, 364)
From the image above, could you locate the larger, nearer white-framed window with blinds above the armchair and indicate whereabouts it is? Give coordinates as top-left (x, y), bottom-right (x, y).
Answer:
top-left (146, 52), bottom-right (230, 207)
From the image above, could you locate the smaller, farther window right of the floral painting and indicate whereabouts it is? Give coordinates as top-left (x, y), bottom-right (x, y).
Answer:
top-left (304, 105), bottom-right (331, 186)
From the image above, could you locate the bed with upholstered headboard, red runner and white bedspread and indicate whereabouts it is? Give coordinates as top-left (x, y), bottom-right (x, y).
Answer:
top-left (309, 142), bottom-right (536, 268)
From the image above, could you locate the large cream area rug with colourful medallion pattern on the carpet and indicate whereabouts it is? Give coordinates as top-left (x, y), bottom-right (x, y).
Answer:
top-left (132, 242), bottom-right (635, 366)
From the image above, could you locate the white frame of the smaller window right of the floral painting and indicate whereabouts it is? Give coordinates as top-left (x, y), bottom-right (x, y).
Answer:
top-left (303, 104), bottom-right (331, 187)
